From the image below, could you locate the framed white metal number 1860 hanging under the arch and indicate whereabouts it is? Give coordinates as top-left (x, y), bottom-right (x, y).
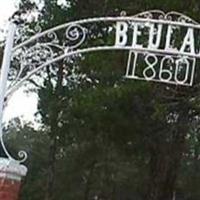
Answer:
top-left (126, 51), bottom-right (196, 86)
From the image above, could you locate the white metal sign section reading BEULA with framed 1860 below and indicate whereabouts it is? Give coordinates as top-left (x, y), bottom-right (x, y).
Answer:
top-left (120, 11), bottom-right (200, 86)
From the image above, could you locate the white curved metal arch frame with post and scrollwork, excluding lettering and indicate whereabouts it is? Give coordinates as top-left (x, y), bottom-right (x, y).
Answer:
top-left (0, 10), bottom-right (200, 163)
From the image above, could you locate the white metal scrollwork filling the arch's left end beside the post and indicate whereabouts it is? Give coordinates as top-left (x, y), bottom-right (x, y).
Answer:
top-left (8, 23), bottom-right (87, 96)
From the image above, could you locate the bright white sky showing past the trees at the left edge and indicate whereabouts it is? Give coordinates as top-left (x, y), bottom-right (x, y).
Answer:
top-left (0, 0), bottom-right (37, 122)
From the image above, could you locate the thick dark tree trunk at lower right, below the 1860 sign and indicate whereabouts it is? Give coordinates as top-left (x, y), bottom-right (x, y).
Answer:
top-left (145, 108), bottom-right (188, 200)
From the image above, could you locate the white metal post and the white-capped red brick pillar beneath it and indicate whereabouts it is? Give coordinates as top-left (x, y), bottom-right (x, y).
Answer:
top-left (0, 22), bottom-right (27, 200)
